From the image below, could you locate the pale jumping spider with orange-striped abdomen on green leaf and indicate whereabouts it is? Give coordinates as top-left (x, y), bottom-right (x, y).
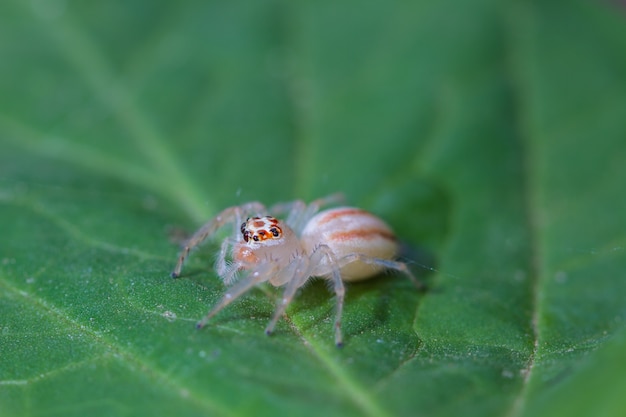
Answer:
top-left (171, 194), bottom-right (422, 346)
